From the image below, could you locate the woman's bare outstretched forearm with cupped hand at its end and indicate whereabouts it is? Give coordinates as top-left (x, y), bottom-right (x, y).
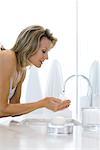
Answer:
top-left (0, 97), bottom-right (70, 117)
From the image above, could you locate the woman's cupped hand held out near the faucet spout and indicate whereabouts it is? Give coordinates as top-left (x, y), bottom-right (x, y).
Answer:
top-left (44, 97), bottom-right (71, 111)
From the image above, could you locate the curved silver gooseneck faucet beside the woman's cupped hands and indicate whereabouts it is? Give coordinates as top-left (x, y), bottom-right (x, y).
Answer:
top-left (63, 74), bottom-right (93, 107)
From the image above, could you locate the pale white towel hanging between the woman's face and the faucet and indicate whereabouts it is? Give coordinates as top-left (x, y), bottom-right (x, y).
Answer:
top-left (45, 60), bottom-right (63, 97)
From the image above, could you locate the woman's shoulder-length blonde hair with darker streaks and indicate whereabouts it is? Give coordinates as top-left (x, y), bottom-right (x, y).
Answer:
top-left (11, 25), bottom-right (57, 67)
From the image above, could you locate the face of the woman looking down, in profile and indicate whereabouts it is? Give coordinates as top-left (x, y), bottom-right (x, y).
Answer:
top-left (29, 37), bottom-right (52, 68)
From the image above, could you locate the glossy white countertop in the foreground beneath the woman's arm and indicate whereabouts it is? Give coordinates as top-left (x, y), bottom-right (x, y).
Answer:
top-left (0, 118), bottom-right (100, 150)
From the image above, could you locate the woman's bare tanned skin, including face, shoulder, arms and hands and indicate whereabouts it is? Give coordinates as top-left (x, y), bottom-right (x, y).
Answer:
top-left (0, 37), bottom-right (70, 117)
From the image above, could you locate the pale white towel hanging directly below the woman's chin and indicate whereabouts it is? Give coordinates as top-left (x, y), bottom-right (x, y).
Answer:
top-left (25, 66), bottom-right (42, 102)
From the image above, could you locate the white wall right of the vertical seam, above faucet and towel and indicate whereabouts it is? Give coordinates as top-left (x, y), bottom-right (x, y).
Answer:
top-left (79, 0), bottom-right (100, 75)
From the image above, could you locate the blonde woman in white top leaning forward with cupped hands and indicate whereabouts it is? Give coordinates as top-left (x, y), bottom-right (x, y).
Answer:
top-left (0, 26), bottom-right (70, 117)
